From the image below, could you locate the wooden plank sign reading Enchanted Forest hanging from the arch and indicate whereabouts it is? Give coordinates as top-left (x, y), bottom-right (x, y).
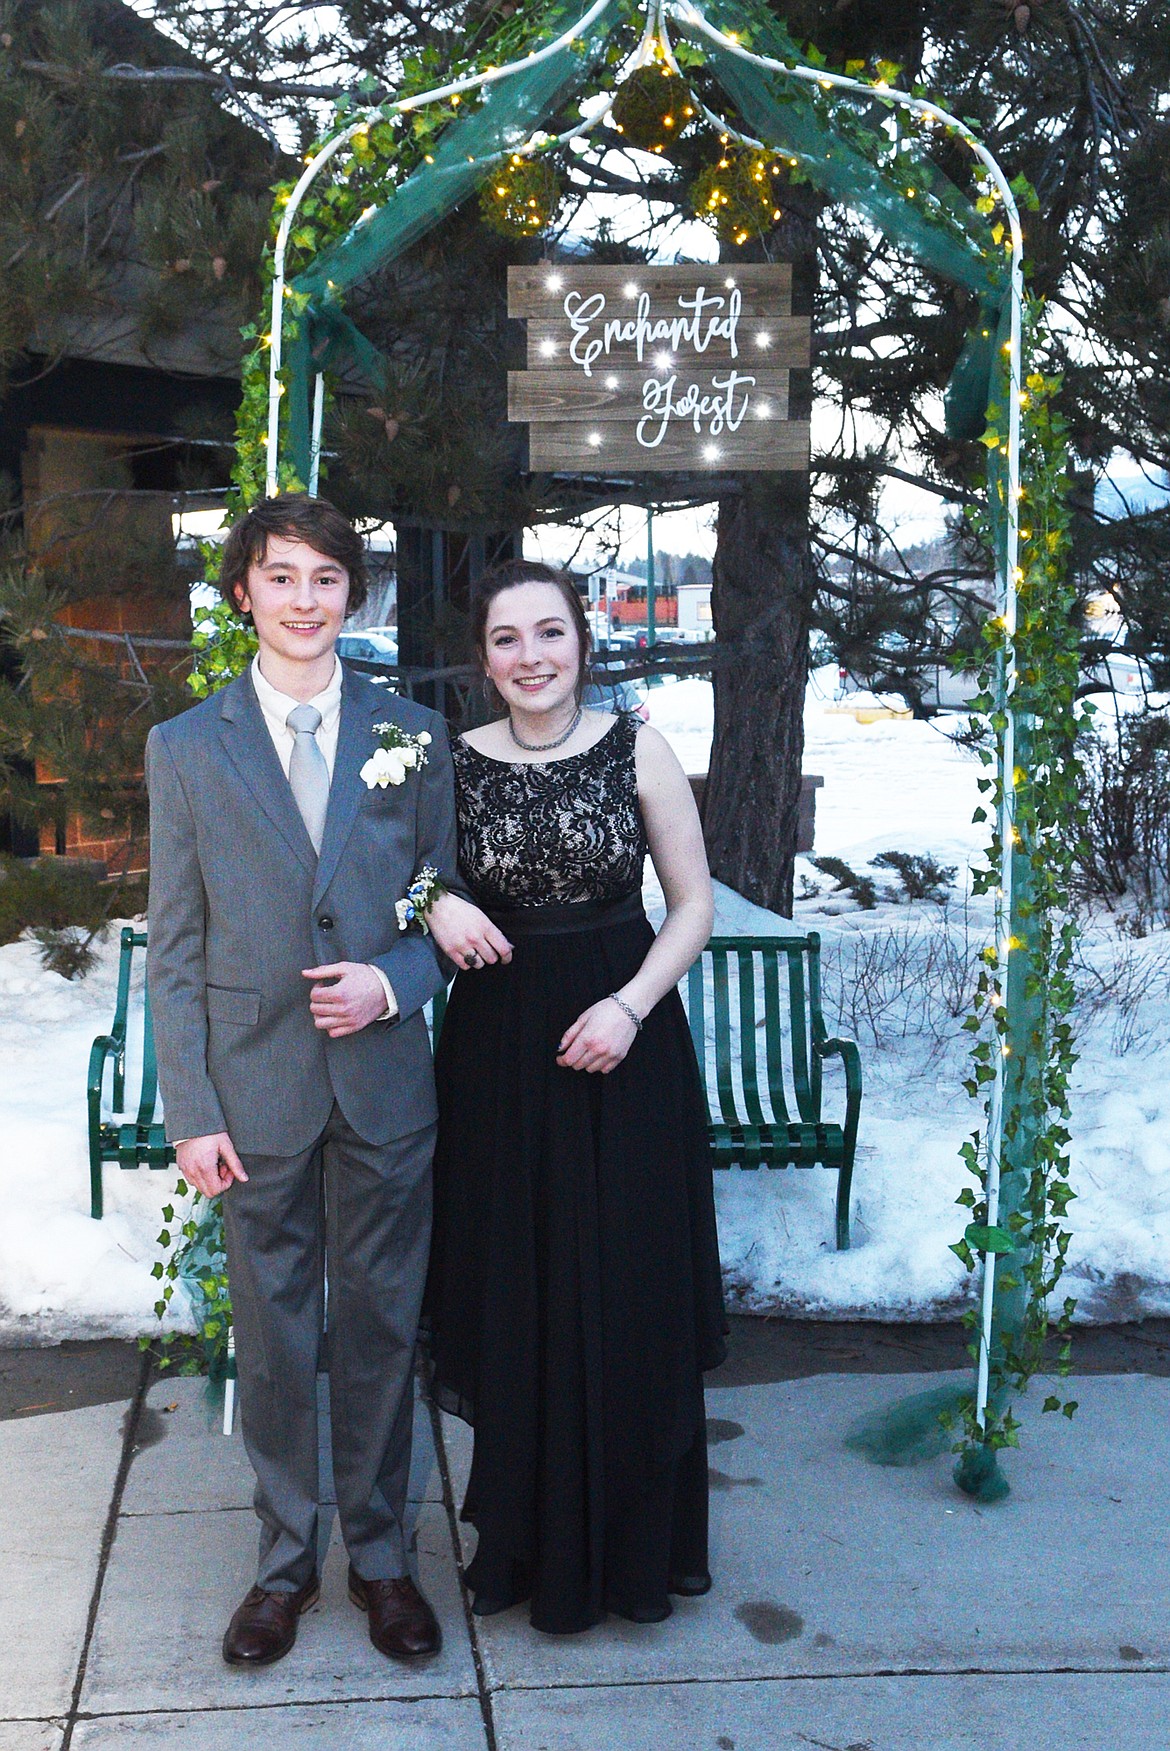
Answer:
top-left (508, 263), bottom-right (811, 475)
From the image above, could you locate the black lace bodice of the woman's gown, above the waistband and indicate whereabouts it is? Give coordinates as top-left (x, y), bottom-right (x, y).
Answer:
top-left (452, 716), bottom-right (646, 909)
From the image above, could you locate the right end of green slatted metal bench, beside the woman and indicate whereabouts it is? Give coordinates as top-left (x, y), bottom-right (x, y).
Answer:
top-left (687, 930), bottom-right (862, 1250)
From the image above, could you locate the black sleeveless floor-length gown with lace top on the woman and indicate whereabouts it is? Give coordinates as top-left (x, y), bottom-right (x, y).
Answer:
top-left (426, 716), bottom-right (725, 1632)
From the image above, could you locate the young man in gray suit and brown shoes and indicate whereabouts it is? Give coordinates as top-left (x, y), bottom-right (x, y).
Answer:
top-left (147, 494), bottom-right (455, 1665)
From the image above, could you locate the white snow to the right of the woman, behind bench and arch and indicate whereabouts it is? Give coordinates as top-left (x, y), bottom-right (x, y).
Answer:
top-left (648, 669), bottom-right (1170, 1320)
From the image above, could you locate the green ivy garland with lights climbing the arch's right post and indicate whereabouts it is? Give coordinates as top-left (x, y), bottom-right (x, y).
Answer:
top-left (951, 301), bottom-right (1084, 1453)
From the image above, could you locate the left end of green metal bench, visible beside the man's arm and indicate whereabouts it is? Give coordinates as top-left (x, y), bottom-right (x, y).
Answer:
top-left (86, 925), bottom-right (175, 1217)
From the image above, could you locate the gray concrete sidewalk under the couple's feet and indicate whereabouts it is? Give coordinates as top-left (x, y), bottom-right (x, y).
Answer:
top-left (0, 1373), bottom-right (1170, 1751)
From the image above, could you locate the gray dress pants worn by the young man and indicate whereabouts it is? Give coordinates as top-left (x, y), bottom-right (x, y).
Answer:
top-left (224, 1105), bottom-right (434, 1592)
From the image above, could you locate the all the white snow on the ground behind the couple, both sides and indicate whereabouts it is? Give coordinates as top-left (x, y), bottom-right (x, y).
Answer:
top-left (0, 671), bottom-right (1170, 1341)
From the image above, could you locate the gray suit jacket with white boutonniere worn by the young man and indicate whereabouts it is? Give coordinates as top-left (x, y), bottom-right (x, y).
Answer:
top-left (147, 669), bottom-right (455, 1156)
